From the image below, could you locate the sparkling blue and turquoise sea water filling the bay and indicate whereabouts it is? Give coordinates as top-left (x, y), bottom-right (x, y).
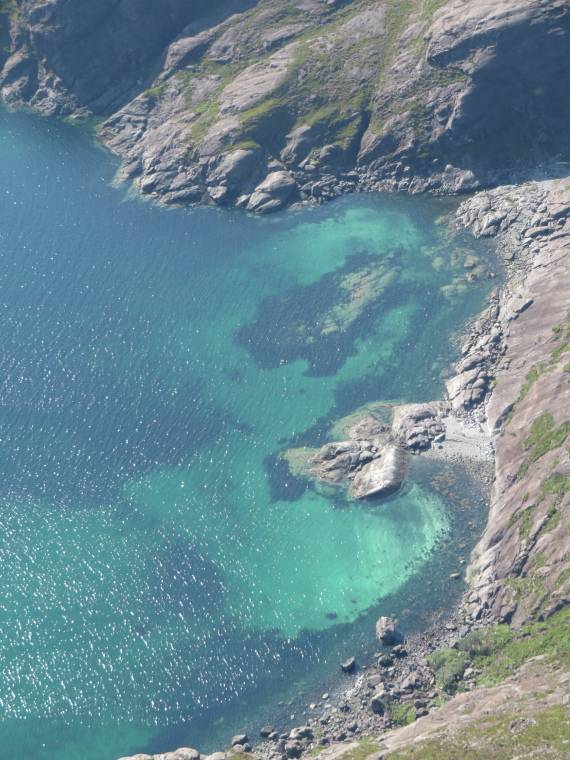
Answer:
top-left (0, 112), bottom-right (487, 760)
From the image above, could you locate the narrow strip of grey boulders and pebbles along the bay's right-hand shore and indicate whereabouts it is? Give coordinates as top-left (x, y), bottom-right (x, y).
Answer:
top-left (116, 180), bottom-right (570, 760)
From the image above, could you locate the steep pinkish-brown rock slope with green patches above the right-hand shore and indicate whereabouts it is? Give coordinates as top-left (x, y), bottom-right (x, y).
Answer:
top-left (460, 178), bottom-right (570, 626)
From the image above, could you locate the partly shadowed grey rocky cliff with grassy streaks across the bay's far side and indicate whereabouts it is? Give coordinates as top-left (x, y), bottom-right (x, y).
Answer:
top-left (0, 0), bottom-right (570, 211)
